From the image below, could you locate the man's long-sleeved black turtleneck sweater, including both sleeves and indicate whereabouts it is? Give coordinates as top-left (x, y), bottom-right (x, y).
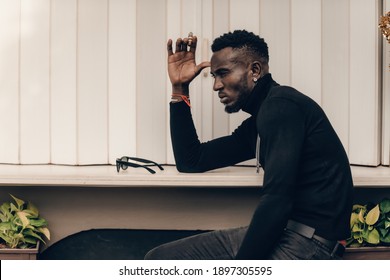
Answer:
top-left (170, 74), bottom-right (353, 259)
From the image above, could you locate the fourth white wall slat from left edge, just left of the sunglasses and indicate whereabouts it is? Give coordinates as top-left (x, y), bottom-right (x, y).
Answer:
top-left (77, 0), bottom-right (108, 164)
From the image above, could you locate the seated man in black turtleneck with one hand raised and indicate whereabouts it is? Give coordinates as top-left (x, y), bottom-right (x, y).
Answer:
top-left (146, 30), bottom-right (353, 259)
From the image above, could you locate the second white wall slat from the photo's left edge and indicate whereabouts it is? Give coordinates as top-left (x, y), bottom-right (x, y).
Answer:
top-left (20, 0), bottom-right (50, 163)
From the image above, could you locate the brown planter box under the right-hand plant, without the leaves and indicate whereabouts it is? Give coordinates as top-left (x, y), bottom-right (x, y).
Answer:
top-left (343, 246), bottom-right (390, 260)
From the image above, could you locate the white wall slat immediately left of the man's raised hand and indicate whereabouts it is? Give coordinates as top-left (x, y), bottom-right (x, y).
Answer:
top-left (136, 0), bottom-right (167, 162)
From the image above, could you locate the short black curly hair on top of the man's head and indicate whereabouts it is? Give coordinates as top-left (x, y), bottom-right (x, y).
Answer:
top-left (211, 30), bottom-right (269, 63)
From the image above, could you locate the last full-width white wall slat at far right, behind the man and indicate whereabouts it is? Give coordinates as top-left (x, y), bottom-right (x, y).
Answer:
top-left (349, 0), bottom-right (380, 165)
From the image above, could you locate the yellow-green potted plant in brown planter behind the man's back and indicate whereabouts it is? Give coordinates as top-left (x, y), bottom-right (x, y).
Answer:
top-left (345, 198), bottom-right (390, 259)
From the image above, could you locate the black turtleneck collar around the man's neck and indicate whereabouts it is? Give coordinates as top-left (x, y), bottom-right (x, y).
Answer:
top-left (242, 73), bottom-right (278, 115)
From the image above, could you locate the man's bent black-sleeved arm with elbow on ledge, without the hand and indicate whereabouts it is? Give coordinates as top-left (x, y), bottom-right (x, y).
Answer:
top-left (170, 102), bottom-right (256, 172)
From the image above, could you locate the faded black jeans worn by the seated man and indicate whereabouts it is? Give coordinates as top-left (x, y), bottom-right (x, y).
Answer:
top-left (145, 227), bottom-right (340, 260)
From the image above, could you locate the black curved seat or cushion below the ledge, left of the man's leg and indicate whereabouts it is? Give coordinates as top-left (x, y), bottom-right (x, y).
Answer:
top-left (38, 229), bottom-right (203, 260)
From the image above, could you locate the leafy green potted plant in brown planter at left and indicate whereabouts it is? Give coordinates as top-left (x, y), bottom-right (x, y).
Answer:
top-left (0, 194), bottom-right (50, 260)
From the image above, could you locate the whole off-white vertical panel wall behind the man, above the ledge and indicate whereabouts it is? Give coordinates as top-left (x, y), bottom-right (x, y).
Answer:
top-left (0, 0), bottom-right (390, 165)
